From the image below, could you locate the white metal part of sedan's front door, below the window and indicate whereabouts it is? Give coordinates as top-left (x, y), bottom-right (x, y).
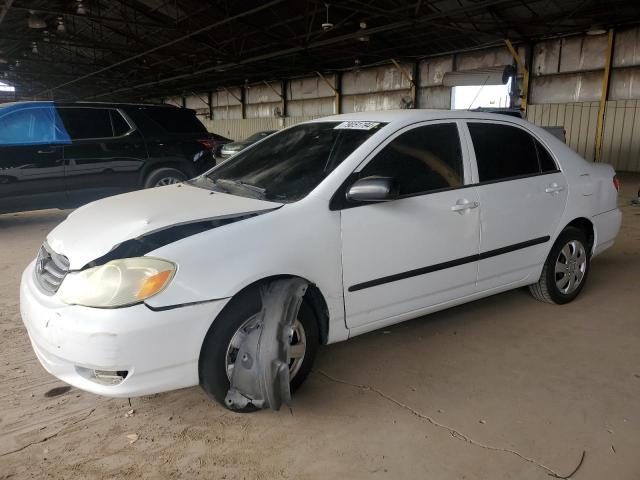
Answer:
top-left (342, 187), bottom-right (479, 328)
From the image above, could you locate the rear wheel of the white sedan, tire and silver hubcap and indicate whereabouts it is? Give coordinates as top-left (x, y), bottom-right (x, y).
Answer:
top-left (529, 227), bottom-right (591, 305)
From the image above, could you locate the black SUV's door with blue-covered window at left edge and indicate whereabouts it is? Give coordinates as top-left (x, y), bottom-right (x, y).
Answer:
top-left (0, 107), bottom-right (66, 213)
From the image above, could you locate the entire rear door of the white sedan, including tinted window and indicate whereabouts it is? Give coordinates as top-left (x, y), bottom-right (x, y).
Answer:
top-left (467, 120), bottom-right (567, 291)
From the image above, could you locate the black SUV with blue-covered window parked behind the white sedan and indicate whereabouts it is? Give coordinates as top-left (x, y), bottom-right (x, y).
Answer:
top-left (0, 102), bottom-right (231, 213)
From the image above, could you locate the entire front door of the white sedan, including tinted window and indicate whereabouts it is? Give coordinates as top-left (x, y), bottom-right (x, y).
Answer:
top-left (341, 121), bottom-right (480, 328)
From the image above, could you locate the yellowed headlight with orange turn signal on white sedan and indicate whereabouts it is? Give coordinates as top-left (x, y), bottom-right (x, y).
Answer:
top-left (59, 257), bottom-right (176, 308)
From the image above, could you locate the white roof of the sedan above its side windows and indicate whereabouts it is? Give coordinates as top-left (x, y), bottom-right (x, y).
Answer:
top-left (310, 109), bottom-right (531, 126)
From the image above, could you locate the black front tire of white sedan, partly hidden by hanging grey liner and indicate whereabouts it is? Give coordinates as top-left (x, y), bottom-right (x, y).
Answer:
top-left (199, 288), bottom-right (319, 413)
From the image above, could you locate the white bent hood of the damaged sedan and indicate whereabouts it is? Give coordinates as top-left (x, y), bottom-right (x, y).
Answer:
top-left (47, 184), bottom-right (282, 270)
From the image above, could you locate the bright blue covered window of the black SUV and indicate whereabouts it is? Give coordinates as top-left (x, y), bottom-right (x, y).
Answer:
top-left (0, 108), bottom-right (55, 145)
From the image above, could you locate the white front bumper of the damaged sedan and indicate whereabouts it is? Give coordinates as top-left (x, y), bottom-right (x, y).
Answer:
top-left (20, 262), bottom-right (227, 397)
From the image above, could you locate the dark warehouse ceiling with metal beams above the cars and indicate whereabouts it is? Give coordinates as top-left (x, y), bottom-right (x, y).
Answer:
top-left (0, 0), bottom-right (640, 100)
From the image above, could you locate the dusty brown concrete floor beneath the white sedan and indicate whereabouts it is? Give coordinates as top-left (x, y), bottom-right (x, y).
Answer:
top-left (0, 176), bottom-right (640, 480)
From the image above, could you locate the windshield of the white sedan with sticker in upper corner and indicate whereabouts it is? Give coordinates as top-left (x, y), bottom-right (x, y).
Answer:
top-left (195, 122), bottom-right (385, 202)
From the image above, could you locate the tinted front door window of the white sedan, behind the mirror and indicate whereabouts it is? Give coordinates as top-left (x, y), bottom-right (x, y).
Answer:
top-left (359, 123), bottom-right (464, 195)
